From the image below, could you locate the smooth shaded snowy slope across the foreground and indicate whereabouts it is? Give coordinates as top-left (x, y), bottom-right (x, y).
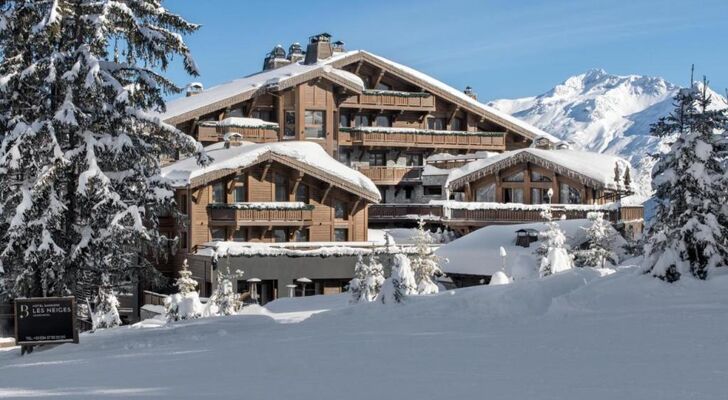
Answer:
top-left (0, 269), bottom-right (728, 400)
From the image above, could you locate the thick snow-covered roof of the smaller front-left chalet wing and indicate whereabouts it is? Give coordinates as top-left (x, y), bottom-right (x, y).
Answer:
top-left (162, 141), bottom-right (381, 202)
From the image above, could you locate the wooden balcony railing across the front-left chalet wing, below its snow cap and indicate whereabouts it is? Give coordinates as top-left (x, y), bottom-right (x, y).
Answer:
top-left (208, 207), bottom-right (313, 226)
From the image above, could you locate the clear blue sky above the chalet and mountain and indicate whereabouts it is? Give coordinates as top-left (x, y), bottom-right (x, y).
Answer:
top-left (165, 0), bottom-right (728, 100)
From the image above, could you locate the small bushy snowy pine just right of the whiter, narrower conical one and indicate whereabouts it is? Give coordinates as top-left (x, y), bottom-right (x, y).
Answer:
top-left (576, 212), bottom-right (619, 268)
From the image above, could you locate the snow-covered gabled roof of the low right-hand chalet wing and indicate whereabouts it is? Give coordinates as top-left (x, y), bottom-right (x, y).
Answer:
top-left (446, 148), bottom-right (629, 189)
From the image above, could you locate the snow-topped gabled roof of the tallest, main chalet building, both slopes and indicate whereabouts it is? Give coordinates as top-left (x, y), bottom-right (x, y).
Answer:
top-left (160, 50), bottom-right (559, 143)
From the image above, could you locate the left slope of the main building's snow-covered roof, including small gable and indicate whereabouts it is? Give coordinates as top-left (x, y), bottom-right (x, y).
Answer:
top-left (160, 51), bottom-right (364, 123)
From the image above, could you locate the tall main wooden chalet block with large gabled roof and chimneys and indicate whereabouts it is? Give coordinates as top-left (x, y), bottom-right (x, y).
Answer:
top-left (161, 34), bottom-right (556, 217)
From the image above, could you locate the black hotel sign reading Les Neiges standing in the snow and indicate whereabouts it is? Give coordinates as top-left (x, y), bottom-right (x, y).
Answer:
top-left (15, 297), bottom-right (78, 354)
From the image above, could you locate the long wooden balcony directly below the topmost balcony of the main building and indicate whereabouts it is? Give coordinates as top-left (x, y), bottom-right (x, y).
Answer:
top-left (339, 127), bottom-right (506, 151)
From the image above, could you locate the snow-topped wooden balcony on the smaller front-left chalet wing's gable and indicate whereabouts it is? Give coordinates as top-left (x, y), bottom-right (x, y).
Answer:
top-left (208, 202), bottom-right (313, 226)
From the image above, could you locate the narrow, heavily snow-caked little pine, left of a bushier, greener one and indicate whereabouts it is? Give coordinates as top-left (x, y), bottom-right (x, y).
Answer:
top-left (536, 208), bottom-right (574, 277)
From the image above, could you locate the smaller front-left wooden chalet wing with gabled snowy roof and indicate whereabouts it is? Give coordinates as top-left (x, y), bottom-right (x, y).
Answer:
top-left (161, 142), bottom-right (379, 275)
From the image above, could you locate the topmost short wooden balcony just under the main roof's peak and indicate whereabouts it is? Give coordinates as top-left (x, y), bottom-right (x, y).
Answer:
top-left (341, 90), bottom-right (435, 111)
